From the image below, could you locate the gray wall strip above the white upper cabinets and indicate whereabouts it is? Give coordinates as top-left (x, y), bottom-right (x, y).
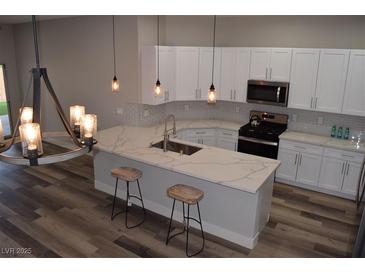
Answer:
top-left (162, 16), bottom-right (365, 48)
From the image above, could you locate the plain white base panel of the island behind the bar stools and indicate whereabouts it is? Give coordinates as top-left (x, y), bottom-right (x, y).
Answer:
top-left (94, 150), bottom-right (266, 248)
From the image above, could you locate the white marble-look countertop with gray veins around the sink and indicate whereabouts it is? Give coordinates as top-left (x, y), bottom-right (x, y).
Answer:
top-left (96, 120), bottom-right (280, 193)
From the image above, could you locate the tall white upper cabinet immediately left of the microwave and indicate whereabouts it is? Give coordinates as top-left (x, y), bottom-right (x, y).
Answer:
top-left (218, 48), bottom-right (250, 102)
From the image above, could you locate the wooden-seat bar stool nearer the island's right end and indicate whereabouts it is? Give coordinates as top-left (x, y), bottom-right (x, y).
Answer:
top-left (166, 184), bottom-right (205, 257)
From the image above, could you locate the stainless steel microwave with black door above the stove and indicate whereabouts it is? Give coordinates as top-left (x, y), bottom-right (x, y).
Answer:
top-left (247, 80), bottom-right (289, 107)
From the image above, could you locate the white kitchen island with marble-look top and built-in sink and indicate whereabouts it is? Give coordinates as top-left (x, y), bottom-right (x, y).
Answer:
top-left (94, 120), bottom-right (280, 248)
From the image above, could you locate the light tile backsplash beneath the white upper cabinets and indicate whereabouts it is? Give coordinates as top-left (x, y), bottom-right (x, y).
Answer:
top-left (118, 101), bottom-right (365, 141)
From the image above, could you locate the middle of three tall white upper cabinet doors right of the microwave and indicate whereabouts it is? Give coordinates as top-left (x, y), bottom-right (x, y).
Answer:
top-left (314, 49), bottom-right (350, 112)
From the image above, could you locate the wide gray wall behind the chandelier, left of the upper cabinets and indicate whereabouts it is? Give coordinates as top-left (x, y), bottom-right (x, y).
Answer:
top-left (14, 16), bottom-right (139, 130)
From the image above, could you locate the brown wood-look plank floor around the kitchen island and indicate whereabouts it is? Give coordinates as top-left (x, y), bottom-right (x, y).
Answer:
top-left (0, 142), bottom-right (360, 257)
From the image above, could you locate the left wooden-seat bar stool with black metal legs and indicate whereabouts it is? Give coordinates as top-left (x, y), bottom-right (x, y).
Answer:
top-left (111, 167), bottom-right (146, 229)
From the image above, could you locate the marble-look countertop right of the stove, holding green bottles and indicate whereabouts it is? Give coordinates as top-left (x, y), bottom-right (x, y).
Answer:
top-left (279, 131), bottom-right (365, 153)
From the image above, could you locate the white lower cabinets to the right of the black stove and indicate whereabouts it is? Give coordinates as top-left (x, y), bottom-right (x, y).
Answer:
top-left (276, 140), bottom-right (364, 198)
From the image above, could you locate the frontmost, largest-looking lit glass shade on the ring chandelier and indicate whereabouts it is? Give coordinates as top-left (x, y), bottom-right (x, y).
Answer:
top-left (19, 123), bottom-right (43, 158)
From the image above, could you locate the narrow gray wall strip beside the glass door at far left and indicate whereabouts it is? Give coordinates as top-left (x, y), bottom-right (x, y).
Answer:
top-left (0, 25), bottom-right (21, 127)
